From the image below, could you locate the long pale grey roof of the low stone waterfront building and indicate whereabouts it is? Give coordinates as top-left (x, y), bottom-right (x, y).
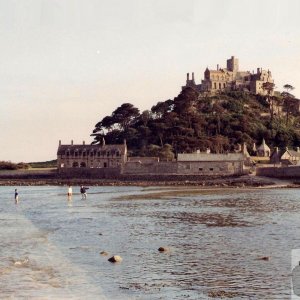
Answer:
top-left (177, 153), bottom-right (245, 161)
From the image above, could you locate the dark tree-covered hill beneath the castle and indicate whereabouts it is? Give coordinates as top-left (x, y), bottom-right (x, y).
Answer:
top-left (91, 88), bottom-right (300, 159)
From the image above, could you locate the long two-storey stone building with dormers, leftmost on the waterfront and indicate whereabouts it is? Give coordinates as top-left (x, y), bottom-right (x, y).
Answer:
top-left (57, 141), bottom-right (127, 169)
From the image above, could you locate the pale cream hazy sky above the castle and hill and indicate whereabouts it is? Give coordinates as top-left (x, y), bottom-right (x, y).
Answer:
top-left (0, 0), bottom-right (300, 162)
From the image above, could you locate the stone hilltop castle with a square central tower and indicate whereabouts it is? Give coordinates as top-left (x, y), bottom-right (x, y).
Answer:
top-left (182, 56), bottom-right (274, 95)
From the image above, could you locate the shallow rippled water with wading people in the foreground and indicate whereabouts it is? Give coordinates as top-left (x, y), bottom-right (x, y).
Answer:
top-left (0, 187), bottom-right (300, 300)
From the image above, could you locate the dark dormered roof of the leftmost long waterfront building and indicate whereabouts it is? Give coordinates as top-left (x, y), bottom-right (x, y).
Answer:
top-left (57, 144), bottom-right (126, 155)
